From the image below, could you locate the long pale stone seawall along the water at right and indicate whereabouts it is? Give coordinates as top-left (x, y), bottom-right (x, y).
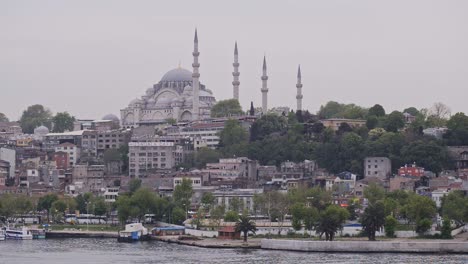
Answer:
top-left (261, 239), bottom-right (468, 254)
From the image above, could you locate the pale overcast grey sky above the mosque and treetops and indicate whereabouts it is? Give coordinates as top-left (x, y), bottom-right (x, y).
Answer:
top-left (0, 0), bottom-right (468, 120)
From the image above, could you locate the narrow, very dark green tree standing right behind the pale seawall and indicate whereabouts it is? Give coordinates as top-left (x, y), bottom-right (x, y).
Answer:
top-left (361, 200), bottom-right (385, 241)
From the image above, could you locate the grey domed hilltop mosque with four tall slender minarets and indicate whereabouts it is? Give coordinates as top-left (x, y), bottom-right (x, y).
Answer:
top-left (120, 30), bottom-right (302, 128)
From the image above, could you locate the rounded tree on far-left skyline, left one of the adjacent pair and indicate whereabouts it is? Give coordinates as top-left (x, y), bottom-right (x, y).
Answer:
top-left (19, 104), bottom-right (52, 134)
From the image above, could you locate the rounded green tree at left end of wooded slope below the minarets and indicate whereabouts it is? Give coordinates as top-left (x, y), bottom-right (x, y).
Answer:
top-left (219, 119), bottom-right (249, 157)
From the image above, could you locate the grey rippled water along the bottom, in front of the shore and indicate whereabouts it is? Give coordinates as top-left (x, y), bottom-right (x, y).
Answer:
top-left (0, 238), bottom-right (468, 264)
